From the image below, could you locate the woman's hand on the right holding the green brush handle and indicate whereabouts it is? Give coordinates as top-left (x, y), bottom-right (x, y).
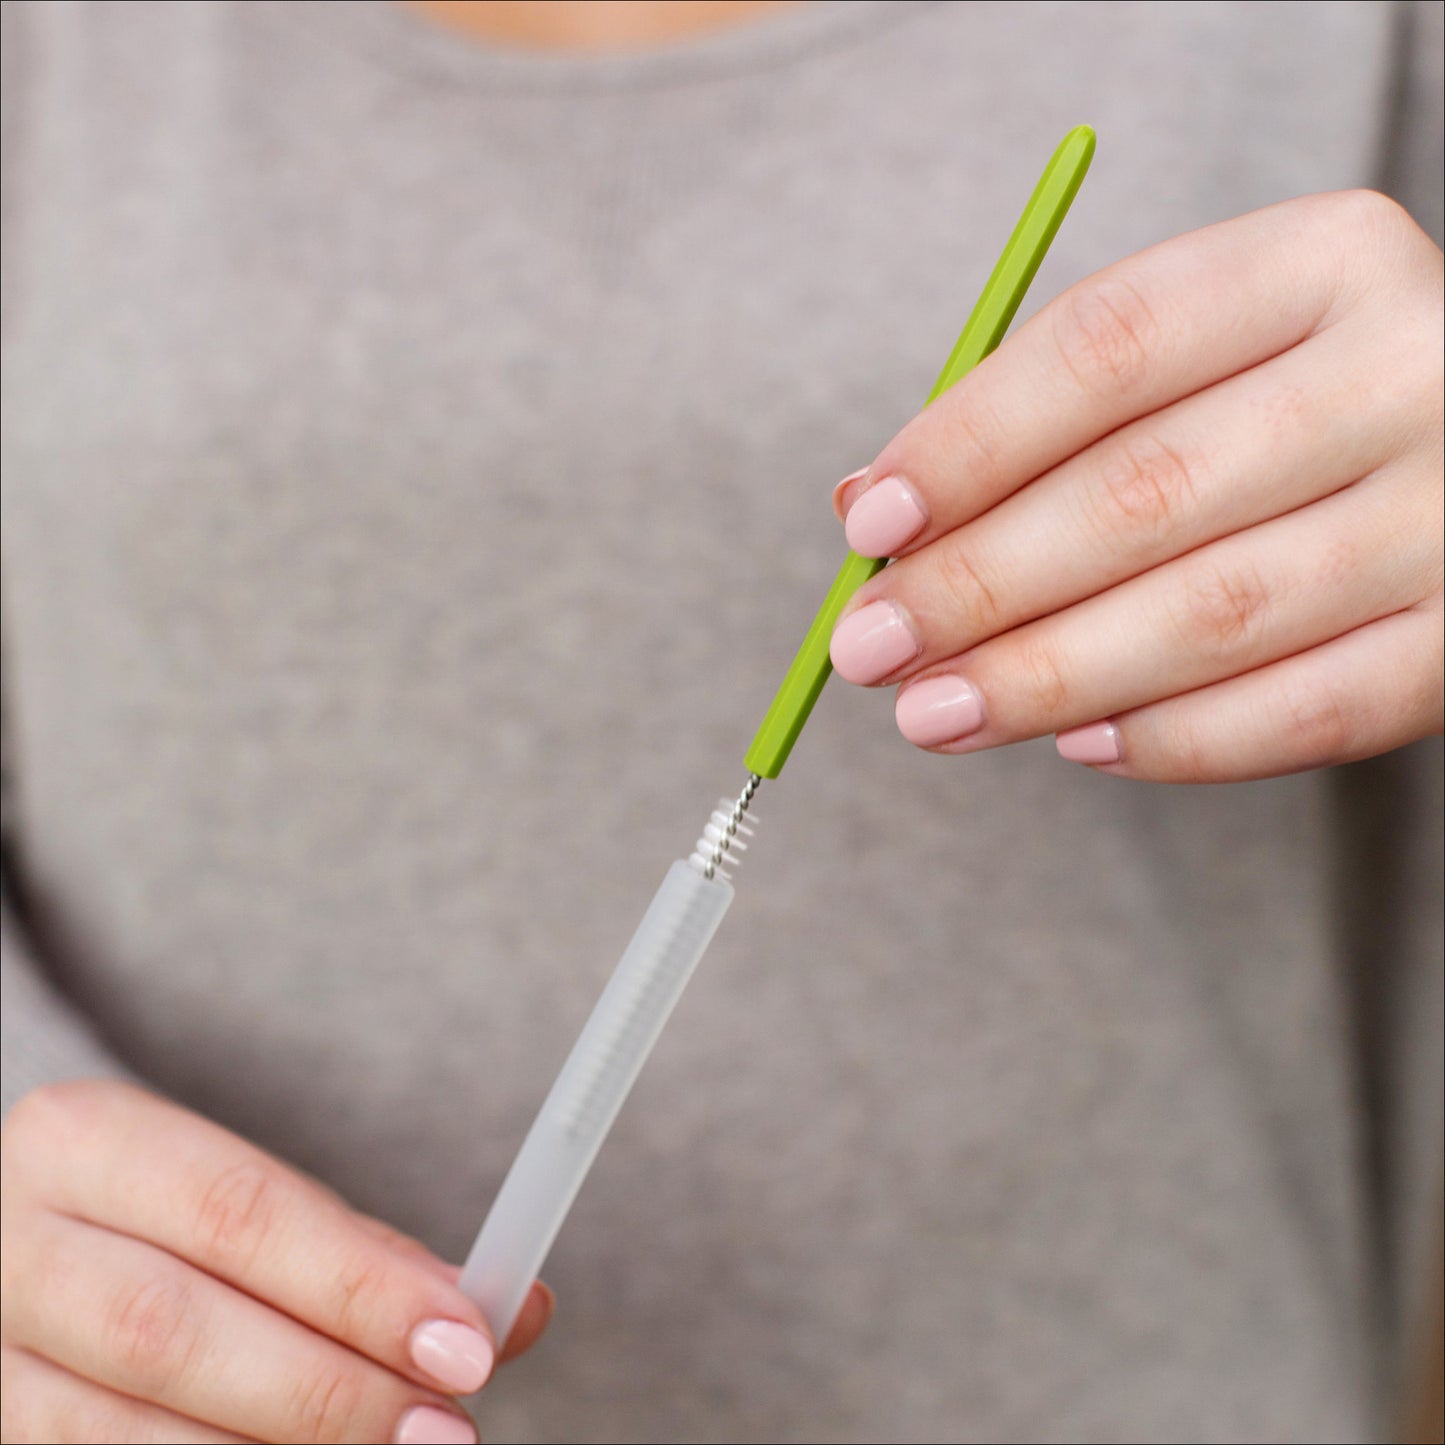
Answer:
top-left (832, 192), bottom-right (1445, 782)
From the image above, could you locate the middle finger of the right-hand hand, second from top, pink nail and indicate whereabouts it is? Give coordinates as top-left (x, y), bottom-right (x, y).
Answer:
top-left (832, 327), bottom-right (1410, 683)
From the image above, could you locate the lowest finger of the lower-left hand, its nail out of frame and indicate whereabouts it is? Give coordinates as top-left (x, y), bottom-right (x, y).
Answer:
top-left (0, 1347), bottom-right (247, 1445)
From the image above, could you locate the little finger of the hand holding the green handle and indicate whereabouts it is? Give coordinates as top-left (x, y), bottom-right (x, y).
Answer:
top-left (1059, 607), bottom-right (1442, 783)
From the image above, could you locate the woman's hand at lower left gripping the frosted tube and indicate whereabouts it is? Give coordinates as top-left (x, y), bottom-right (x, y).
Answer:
top-left (0, 1081), bottom-right (551, 1442)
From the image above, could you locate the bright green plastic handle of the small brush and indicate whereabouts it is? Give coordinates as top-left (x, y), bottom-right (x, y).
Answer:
top-left (746, 126), bottom-right (1094, 777)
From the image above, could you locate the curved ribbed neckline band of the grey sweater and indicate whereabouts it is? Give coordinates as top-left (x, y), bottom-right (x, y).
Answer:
top-left (284, 0), bottom-right (929, 91)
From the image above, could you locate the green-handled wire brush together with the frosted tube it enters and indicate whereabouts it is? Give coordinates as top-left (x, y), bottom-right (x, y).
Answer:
top-left (461, 126), bottom-right (1094, 1345)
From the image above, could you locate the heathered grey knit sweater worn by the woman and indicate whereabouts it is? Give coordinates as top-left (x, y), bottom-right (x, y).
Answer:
top-left (3, 3), bottom-right (1441, 1441)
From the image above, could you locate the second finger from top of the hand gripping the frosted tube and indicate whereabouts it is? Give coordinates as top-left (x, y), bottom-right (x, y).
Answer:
top-left (4, 1214), bottom-right (475, 1442)
